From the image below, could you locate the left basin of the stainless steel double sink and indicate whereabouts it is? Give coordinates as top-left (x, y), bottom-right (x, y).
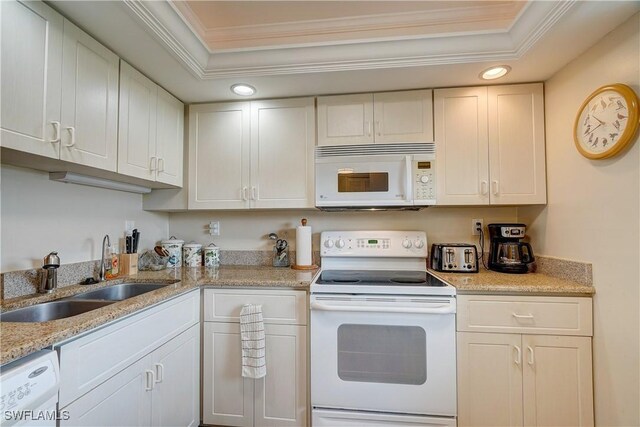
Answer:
top-left (0, 300), bottom-right (113, 322)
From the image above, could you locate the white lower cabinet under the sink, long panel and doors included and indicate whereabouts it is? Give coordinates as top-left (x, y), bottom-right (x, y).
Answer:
top-left (59, 291), bottom-right (200, 427)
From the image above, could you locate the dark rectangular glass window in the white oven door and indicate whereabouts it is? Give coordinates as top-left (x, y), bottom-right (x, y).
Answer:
top-left (338, 324), bottom-right (427, 385)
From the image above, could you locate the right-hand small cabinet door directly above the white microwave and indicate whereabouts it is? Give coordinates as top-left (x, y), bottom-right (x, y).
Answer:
top-left (373, 90), bottom-right (433, 144)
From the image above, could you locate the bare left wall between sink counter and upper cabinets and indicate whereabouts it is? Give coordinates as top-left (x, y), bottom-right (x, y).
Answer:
top-left (0, 165), bottom-right (169, 272)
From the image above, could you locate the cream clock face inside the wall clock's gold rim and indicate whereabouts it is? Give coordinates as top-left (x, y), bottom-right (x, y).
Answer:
top-left (577, 90), bottom-right (629, 154)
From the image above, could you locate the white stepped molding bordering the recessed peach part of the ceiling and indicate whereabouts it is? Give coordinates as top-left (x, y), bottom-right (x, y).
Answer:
top-left (124, 0), bottom-right (578, 80)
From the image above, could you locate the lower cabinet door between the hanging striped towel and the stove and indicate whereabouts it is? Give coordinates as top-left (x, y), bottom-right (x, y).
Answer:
top-left (255, 325), bottom-right (307, 427)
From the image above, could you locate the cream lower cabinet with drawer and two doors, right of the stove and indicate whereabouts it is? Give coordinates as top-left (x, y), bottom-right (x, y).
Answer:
top-left (457, 295), bottom-right (593, 426)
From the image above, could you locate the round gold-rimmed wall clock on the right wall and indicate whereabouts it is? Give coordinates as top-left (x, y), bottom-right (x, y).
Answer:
top-left (573, 83), bottom-right (639, 159)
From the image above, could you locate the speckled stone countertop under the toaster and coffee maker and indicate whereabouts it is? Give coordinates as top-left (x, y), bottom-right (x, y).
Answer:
top-left (429, 268), bottom-right (595, 297)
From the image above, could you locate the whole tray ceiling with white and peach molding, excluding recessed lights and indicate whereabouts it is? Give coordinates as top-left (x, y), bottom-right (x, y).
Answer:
top-left (49, 0), bottom-right (640, 103)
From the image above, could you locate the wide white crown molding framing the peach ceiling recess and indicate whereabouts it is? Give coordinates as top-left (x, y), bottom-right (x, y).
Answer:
top-left (124, 0), bottom-right (578, 80)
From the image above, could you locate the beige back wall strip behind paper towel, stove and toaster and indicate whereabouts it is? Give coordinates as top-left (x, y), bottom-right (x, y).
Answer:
top-left (169, 207), bottom-right (516, 254)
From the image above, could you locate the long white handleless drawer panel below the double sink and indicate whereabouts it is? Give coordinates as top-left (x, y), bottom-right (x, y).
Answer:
top-left (59, 290), bottom-right (200, 408)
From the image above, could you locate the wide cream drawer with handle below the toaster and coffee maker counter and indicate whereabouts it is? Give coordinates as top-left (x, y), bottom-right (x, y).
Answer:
top-left (457, 295), bottom-right (593, 336)
